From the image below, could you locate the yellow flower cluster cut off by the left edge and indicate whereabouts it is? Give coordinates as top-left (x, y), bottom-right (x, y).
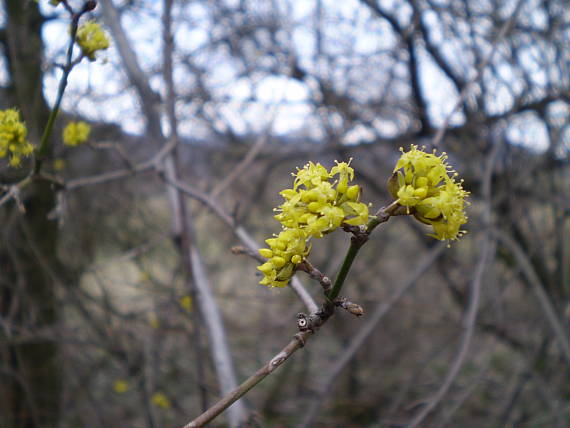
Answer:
top-left (0, 109), bottom-right (34, 167)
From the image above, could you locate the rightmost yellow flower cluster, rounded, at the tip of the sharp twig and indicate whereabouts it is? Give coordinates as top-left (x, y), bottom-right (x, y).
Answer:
top-left (389, 145), bottom-right (469, 241)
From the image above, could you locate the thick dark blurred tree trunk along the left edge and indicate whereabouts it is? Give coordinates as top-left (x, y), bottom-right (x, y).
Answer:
top-left (0, 0), bottom-right (60, 427)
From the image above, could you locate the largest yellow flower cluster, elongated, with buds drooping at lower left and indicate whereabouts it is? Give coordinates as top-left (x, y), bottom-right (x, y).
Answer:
top-left (258, 162), bottom-right (368, 287)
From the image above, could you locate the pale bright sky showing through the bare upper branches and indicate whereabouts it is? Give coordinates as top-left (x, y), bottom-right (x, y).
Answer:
top-left (0, 0), bottom-right (547, 151)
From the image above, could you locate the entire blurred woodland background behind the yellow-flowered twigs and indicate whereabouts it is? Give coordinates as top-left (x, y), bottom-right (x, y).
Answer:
top-left (0, 0), bottom-right (570, 428)
